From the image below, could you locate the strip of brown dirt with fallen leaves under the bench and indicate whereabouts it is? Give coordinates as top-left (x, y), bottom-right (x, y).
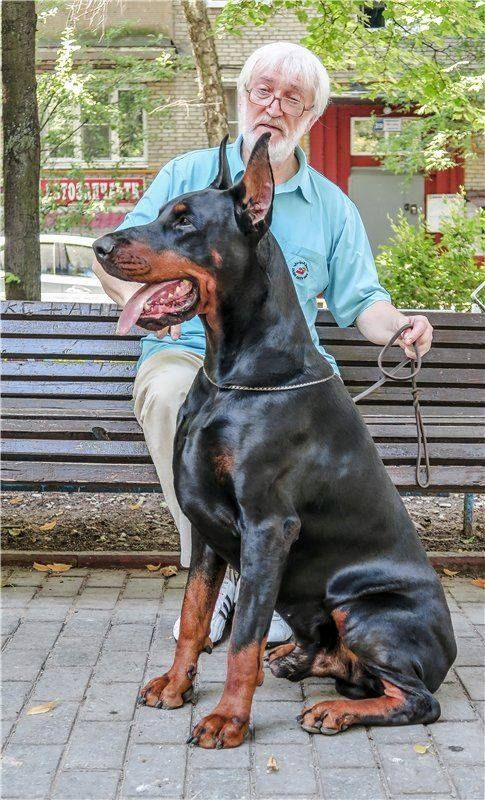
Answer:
top-left (2, 492), bottom-right (485, 552)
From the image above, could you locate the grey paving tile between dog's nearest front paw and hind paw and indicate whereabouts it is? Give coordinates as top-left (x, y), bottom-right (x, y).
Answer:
top-left (252, 701), bottom-right (308, 744)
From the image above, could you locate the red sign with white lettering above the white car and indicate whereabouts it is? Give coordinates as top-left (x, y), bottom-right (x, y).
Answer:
top-left (40, 178), bottom-right (145, 206)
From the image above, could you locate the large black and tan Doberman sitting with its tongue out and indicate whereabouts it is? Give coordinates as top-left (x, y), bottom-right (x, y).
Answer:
top-left (94, 134), bottom-right (455, 748)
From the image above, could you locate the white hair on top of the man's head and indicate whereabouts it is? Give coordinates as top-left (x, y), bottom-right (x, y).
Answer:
top-left (237, 42), bottom-right (330, 117)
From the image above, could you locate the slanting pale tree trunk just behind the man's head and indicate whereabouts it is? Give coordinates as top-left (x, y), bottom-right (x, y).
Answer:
top-left (182, 0), bottom-right (228, 147)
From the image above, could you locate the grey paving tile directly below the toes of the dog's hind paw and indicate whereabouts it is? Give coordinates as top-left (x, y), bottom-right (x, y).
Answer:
top-left (312, 727), bottom-right (375, 771)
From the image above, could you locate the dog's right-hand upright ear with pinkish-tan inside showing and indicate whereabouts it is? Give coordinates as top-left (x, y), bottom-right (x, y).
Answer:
top-left (232, 133), bottom-right (274, 233)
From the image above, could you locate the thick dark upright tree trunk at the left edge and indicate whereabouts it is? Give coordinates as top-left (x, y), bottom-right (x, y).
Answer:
top-left (2, 0), bottom-right (40, 300)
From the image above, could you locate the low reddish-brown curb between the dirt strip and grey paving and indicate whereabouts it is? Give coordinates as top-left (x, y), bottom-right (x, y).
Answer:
top-left (2, 550), bottom-right (485, 572)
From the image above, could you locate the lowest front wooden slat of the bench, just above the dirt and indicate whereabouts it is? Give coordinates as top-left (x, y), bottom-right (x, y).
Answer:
top-left (1, 461), bottom-right (485, 494)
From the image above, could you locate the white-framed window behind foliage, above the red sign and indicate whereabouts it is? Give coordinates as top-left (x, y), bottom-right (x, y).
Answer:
top-left (45, 89), bottom-right (147, 166)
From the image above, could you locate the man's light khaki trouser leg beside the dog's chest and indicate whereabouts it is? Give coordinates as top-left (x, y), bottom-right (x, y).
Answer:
top-left (133, 348), bottom-right (204, 567)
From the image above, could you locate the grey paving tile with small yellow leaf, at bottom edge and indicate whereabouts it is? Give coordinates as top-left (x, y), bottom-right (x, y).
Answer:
top-left (255, 744), bottom-right (318, 800)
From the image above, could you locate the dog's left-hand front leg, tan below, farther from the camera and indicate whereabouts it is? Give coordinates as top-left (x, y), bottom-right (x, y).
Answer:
top-left (139, 528), bottom-right (226, 708)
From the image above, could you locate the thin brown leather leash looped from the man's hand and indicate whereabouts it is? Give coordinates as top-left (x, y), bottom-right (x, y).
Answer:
top-left (353, 325), bottom-right (431, 489)
